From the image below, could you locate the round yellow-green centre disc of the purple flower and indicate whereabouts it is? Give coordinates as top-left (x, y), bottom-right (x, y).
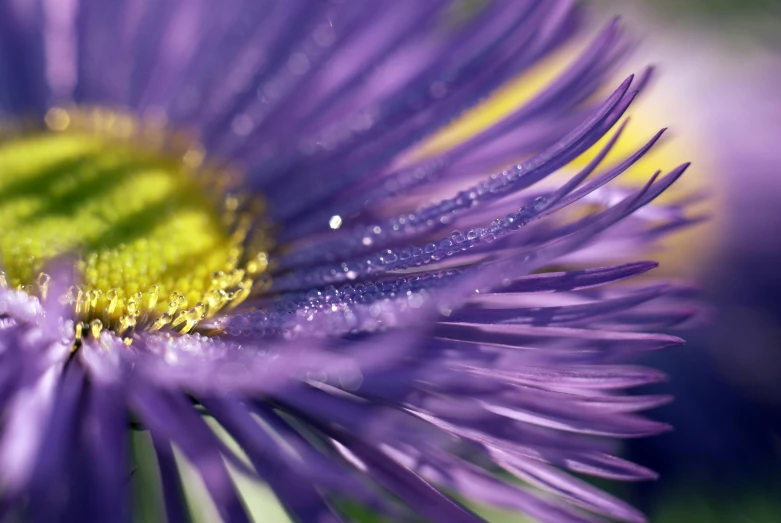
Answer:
top-left (0, 109), bottom-right (267, 338)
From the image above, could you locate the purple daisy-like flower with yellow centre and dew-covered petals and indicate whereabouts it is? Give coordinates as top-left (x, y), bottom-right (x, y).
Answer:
top-left (0, 0), bottom-right (689, 523)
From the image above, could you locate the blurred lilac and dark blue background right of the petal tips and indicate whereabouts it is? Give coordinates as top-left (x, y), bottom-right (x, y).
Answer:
top-left (596, 0), bottom-right (781, 523)
